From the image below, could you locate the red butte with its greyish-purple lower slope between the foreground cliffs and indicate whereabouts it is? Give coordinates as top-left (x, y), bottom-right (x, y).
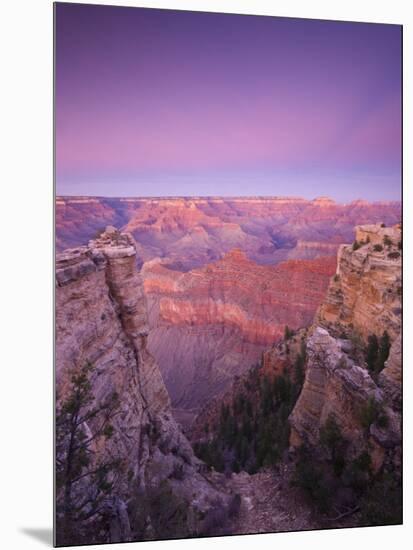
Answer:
top-left (142, 249), bottom-right (336, 409)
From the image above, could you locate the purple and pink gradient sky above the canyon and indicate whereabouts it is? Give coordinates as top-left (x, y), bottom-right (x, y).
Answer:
top-left (56, 3), bottom-right (401, 201)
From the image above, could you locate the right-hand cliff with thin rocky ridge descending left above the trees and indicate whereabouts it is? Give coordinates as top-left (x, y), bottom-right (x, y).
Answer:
top-left (191, 225), bottom-right (402, 462)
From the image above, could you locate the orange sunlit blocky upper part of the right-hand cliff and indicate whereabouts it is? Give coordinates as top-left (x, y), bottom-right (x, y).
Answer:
top-left (316, 225), bottom-right (401, 341)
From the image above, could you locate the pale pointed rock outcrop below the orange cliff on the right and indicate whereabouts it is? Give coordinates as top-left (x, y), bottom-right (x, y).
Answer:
top-left (290, 327), bottom-right (401, 470)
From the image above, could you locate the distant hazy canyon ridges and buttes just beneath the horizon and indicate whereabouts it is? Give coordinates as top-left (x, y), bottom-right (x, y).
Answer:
top-left (56, 197), bottom-right (401, 270)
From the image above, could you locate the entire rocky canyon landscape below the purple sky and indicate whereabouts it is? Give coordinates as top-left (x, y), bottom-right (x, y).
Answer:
top-left (56, 203), bottom-right (402, 544)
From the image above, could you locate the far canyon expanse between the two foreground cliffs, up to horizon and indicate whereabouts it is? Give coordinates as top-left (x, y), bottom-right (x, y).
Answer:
top-left (56, 197), bottom-right (400, 427)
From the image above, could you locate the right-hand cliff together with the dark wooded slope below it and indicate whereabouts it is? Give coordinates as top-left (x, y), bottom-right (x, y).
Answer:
top-left (192, 224), bottom-right (402, 532)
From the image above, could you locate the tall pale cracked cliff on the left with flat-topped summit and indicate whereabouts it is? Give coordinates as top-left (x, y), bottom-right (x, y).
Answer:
top-left (56, 228), bottom-right (229, 542)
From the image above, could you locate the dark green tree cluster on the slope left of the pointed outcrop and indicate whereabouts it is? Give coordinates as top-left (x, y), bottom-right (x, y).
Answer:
top-left (194, 360), bottom-right (306, 473)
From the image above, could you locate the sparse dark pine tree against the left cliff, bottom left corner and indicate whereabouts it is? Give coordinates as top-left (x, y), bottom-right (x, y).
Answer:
top-left (56, 363), bottom-right (121, 544)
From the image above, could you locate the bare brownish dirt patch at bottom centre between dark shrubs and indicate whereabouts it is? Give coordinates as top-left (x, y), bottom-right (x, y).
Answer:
top-left (229, 468), bottom-right (318, 534)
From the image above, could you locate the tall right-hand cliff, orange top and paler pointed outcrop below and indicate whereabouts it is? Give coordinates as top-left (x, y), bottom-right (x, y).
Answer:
top-left (290, 225), bottom-right (401, 471)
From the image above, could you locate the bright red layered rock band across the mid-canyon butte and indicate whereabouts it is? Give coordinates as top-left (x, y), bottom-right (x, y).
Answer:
top-left (142, 250), bottom-right (336, 345)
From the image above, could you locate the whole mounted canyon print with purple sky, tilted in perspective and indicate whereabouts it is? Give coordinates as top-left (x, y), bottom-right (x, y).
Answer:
top-left (54, 3), bottom-right (402, 546)
